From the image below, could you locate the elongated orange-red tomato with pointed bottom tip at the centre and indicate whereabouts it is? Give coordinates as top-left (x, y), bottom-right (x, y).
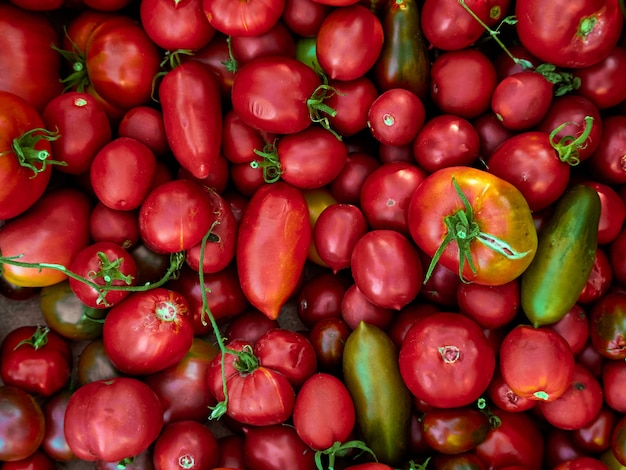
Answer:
top-left (235, 181), bottom-right (311, 319)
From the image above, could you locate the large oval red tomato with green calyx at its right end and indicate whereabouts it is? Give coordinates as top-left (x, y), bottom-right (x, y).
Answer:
top-left (232, 56), bottom-right (332, 134)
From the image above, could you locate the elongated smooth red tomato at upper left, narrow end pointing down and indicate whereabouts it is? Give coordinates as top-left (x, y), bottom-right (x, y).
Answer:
top-left (159, 60), bottom-right (222, 179)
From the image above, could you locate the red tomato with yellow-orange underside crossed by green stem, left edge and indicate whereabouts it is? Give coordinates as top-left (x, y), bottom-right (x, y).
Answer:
top-left (0, 187), bottom-right (91, 287)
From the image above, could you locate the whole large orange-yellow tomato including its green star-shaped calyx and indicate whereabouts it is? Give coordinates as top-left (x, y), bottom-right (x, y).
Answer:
top-left (408, 167), bottom-right (537, 285)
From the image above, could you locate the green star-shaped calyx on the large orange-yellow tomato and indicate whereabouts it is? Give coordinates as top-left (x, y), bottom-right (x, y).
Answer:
top-left (424, 177), bottom-right (529, 284)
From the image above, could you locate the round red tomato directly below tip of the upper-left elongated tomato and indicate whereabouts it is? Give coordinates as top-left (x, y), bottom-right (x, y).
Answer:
top-left (139, 179), bottom-right (213, 253)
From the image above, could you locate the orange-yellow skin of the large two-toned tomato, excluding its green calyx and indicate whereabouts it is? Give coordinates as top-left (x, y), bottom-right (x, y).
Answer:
top-left (408, 167), bottom-right (537, 285)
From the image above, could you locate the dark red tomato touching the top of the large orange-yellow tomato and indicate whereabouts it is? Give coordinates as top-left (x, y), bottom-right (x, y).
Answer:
top-left (413, 114), bottom-right (480, 173)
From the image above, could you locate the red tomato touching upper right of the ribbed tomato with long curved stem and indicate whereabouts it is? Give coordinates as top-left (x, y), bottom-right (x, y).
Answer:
top-left (254, 328), bottom-right (317, 389)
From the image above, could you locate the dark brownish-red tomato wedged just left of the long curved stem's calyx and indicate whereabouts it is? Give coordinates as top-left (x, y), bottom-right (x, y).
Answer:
top-left (144, 337), bottom-right (217, 424)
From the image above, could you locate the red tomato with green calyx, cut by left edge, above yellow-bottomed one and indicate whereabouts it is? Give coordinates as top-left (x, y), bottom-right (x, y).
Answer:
top-left (0, 91), bottom-right (62, 220)
